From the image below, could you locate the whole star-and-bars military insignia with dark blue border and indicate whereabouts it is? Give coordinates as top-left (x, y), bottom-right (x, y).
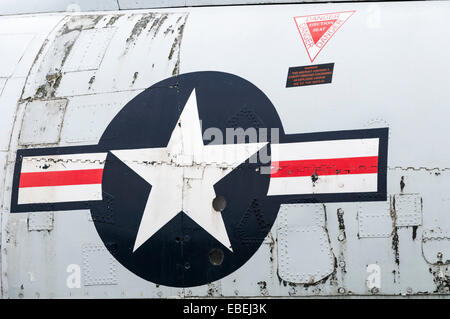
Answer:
top-left (11, 72), bottom-right (388, 287)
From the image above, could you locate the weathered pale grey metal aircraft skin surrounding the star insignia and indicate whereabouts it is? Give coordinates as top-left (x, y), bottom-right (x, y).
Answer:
top-left (0, 2), bottom-right (450, 298)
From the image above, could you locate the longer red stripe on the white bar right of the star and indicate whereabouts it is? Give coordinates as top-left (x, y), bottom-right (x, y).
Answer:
top-left (270, 156), bottom-right (378, 177)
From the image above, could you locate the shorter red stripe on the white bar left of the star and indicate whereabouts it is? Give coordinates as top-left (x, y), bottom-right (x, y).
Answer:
top-left (19, 169), bottom-right (103, 188)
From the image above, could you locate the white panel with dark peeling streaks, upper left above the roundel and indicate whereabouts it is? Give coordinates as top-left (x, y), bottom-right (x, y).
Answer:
top-left (21, 12), bottom-right (188, 101)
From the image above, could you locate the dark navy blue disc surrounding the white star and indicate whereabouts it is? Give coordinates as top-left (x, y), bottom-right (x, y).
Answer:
top-left (91, 72), bottom-right (282, 287)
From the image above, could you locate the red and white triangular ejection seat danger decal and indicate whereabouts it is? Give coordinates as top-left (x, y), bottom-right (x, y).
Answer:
top-left (294, 11), bottom-right (355, 62)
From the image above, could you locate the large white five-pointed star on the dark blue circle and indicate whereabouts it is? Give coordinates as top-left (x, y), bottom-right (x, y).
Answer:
top-left (111, 90), bottom-right (267, 252)
